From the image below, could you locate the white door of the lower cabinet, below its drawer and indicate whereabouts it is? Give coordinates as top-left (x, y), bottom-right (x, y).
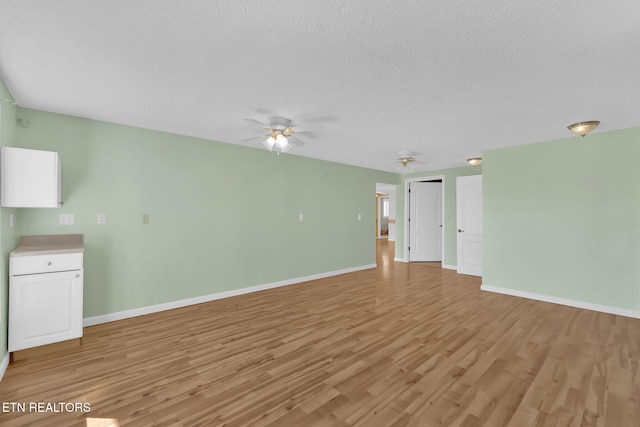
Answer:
top-left (9, 270), bottom-right (83, 351)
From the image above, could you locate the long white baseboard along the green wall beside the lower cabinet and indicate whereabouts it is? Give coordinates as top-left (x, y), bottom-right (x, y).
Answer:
top-left (83, 264), bottom-right (376, 326)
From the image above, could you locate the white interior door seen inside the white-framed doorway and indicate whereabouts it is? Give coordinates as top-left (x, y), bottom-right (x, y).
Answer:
top-left (409, 182), bottom-right (442, 261)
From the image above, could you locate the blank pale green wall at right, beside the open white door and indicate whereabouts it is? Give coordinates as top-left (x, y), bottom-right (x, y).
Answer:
top-left (483, 128), bottom-right (640, 310)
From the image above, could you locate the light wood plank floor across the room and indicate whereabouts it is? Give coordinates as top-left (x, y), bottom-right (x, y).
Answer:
top-left (0, 240), bottom-right (640, 427)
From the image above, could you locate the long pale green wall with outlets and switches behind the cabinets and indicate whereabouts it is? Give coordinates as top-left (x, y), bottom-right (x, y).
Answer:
top-left (10, 108), bottom-right (399, 317)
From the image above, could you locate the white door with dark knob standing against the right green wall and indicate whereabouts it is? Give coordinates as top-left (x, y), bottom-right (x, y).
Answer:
top-left (456, 175), bottom-right (482, 276)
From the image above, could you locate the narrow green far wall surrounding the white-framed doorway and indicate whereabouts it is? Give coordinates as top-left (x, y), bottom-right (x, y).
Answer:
top-left (396, 166), bottom-right (482, 267)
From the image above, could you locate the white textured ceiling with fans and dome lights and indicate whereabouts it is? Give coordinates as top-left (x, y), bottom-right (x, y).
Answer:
top-left (0, 0), bottom-right (640, 171)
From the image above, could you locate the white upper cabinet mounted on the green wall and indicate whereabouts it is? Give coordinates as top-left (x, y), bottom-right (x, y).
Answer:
top-left (0, 147), bottom-right (62, 208)
